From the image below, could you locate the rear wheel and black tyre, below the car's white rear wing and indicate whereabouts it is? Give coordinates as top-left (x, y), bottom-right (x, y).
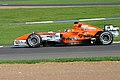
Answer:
top-left (97, 31), bottom-right (113, 45)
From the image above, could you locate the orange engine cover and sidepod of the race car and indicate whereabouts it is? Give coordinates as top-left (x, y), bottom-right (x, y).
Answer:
top-left (62, 23), bottom-right (103, 43)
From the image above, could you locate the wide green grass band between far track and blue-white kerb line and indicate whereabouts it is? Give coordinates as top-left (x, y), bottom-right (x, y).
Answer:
top-left (0, 6), bottom-right (120, 22)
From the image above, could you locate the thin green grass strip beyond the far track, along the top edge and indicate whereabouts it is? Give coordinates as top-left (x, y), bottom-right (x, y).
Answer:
top-left (0, 0), bottom-right (120, 4)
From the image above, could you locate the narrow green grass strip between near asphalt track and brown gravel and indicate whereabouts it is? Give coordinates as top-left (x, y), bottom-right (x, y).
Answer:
top-left (0, 57), bottom-right (120, 64)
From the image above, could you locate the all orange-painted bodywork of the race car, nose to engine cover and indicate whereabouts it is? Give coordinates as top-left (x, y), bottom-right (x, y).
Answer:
top-left (16, 23), bottom-right (103, 44)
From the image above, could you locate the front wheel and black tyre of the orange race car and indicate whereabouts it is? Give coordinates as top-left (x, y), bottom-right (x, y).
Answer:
top-left (27, 33), bottom-right (42, 48)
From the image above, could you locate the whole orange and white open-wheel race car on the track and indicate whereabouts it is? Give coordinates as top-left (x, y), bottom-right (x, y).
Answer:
top-left (14, 22), bottom-right (119, 48)
